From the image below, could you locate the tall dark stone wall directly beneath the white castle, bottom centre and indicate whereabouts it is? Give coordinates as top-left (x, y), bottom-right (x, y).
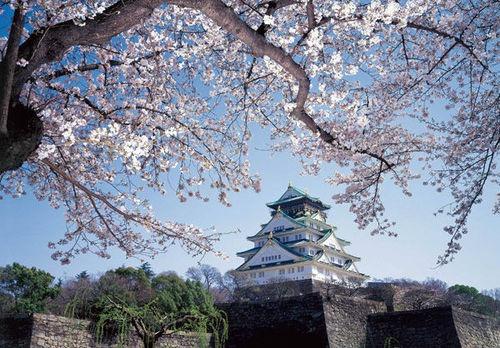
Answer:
top-left (220, 292), bottom-right (384, 348)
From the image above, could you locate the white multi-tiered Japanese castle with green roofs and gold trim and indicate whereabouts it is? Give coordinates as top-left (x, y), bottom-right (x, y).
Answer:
top-left (236, 185), bottom-right (368, 285)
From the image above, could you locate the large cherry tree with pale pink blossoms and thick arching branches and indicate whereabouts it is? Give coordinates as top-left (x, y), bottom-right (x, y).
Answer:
top-left (0, 0), bottom-right (500, 264)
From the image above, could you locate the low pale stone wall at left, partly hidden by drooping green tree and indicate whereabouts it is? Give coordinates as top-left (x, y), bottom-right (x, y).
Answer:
top-left (0, 314), bottom-right (213, 348)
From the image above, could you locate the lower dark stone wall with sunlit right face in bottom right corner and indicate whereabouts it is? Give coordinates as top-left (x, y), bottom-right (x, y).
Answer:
top-left (366, 306), bottom-right (500, 348)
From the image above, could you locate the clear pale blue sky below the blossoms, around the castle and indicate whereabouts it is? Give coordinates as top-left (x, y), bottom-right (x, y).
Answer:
top-left (0, 7), bottom-right (500, 289)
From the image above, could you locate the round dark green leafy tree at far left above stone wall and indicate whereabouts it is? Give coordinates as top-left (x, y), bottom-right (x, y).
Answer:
top-left (0, 262), bottom-right (60, 314)
